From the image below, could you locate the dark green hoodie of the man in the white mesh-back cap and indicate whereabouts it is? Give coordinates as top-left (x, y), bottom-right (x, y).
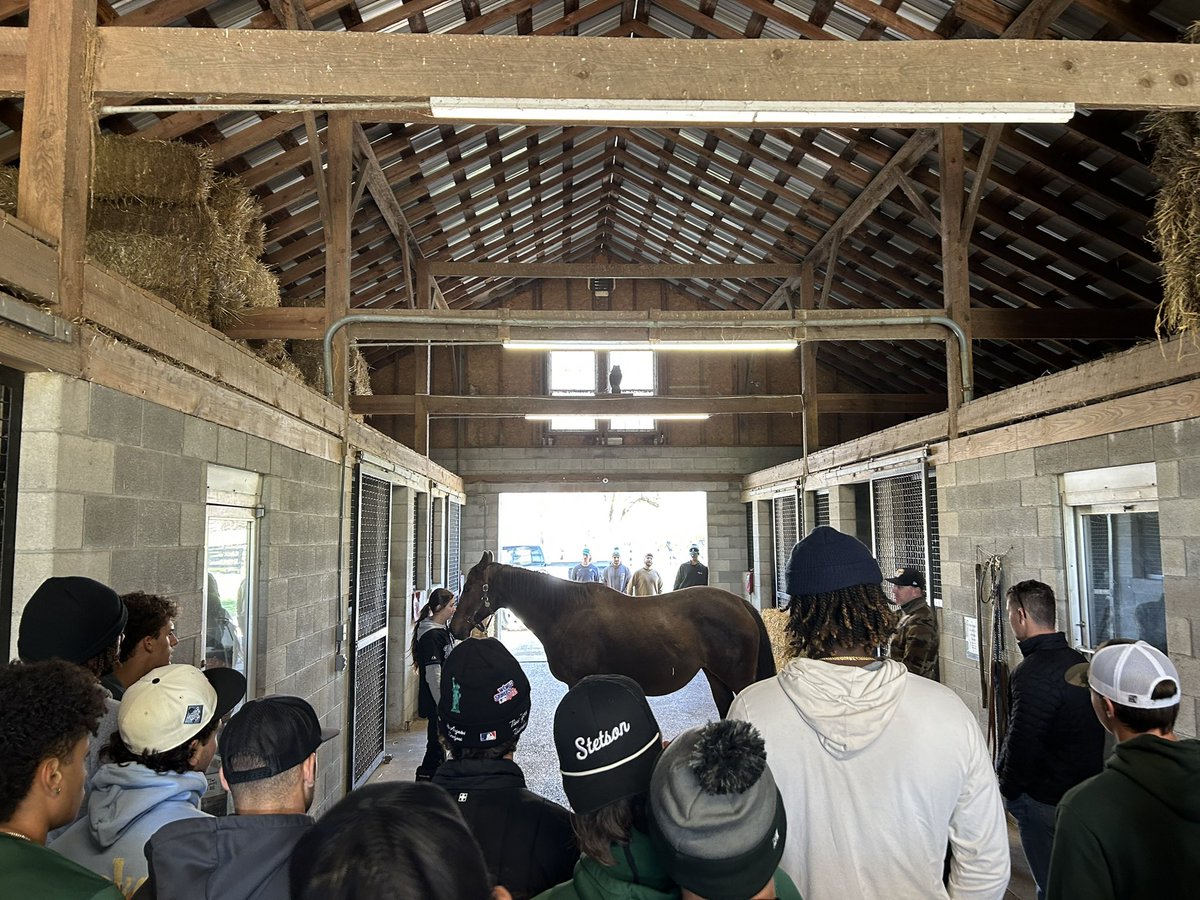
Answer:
top-left (1046, 734), bottom-right (1200, 900)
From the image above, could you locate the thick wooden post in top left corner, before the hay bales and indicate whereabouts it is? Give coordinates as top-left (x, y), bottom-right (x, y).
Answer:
top-left (17, 0), bottom-right (96, 319)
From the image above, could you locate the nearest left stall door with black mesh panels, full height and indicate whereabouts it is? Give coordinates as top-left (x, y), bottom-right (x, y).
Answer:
top-left (349, 467), bottom-right (391, 787)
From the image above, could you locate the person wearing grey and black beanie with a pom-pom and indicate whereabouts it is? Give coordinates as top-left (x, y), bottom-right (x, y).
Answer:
top-left (650, 719), bottom-right (802, 900)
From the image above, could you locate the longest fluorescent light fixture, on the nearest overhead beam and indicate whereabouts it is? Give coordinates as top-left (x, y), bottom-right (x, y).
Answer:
top-left (430, 97), bottom-right (1075, 126)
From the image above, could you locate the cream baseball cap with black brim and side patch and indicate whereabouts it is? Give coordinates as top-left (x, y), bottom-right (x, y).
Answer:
top-left (116, 665), bottom-right (246, 756)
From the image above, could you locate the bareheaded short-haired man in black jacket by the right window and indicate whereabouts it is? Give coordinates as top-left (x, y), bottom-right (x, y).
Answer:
top-left (997, 581), bottom-right (1104, 900)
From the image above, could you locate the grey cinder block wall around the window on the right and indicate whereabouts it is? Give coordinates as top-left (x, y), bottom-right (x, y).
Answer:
top-left (937, 419), bottom-right (1200, 736)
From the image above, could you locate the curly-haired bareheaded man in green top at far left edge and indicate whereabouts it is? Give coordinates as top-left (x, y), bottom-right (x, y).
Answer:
top-left (0, 660), bottom-right (122, 900)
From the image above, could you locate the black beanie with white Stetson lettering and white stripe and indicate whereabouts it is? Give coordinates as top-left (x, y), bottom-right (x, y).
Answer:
top-left (554, 676), bottom-right (662, 814)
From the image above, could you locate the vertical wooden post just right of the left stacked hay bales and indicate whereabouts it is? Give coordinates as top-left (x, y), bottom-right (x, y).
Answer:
top-left (324, 113), bottom-right (354, 408)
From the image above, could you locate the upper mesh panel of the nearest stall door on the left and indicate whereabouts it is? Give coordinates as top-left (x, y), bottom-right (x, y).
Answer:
top-left (350, 472), bottom-right (391, 638)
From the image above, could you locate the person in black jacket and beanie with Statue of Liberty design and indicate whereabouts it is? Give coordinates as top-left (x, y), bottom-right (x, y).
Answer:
top-left (433, 637), bottom-right (580, 900)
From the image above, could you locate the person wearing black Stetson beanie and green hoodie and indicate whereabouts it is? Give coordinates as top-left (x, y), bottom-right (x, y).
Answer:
top-left (539, 676), bottom-right (679, 900)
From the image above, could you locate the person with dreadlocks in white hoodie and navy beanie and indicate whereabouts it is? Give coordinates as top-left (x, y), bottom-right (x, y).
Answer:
top-left (730, 526), bottom-right (1009, 900)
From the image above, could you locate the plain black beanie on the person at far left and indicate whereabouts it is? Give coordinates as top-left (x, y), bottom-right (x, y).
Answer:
top-left (17, 575), bottom-right (130, 665)
